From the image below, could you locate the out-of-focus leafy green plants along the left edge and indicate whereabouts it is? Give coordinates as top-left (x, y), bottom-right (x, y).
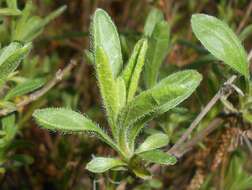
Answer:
top-left (0, 0), bottom-right (66, 173)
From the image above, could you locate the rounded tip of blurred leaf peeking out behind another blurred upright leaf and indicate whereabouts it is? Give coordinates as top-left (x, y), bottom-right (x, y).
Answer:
top-left (144, 8), bottom-right (164, 37)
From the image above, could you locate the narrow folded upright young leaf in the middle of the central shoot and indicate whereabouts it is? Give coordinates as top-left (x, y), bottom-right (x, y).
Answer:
top-left (122, 39), bottom-right (148, 102)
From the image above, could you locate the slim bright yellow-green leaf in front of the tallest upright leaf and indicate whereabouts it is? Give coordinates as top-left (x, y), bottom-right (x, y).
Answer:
top-left (95, 48), bottom-right (119, 136)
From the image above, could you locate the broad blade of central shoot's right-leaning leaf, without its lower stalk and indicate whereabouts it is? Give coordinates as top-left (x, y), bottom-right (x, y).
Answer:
top-left (119, 70), bottom-right (202, 126)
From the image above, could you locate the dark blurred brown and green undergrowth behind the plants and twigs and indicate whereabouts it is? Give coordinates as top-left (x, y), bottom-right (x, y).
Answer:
top-left (0, 0), bottom-right (252, 190)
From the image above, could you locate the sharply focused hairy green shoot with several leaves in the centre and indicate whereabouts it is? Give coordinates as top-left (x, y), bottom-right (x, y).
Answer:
top-left (33, 9), bottom-right (202, 178)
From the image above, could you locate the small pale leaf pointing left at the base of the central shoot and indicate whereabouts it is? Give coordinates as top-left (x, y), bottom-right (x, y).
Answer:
top-left (86, 157), bottom-right (126, 173)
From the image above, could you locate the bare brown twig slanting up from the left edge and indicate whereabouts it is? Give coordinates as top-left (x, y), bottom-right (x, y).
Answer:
top-left (0, 60), bottom-right (77, 117)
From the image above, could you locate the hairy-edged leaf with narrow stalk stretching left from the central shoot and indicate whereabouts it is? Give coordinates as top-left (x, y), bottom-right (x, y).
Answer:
top-left (33, 108), bottom-right (117, 153)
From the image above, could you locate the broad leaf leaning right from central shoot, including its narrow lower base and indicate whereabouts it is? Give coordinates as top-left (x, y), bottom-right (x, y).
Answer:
top-left (118, 70), bottom-right (202, 154)
